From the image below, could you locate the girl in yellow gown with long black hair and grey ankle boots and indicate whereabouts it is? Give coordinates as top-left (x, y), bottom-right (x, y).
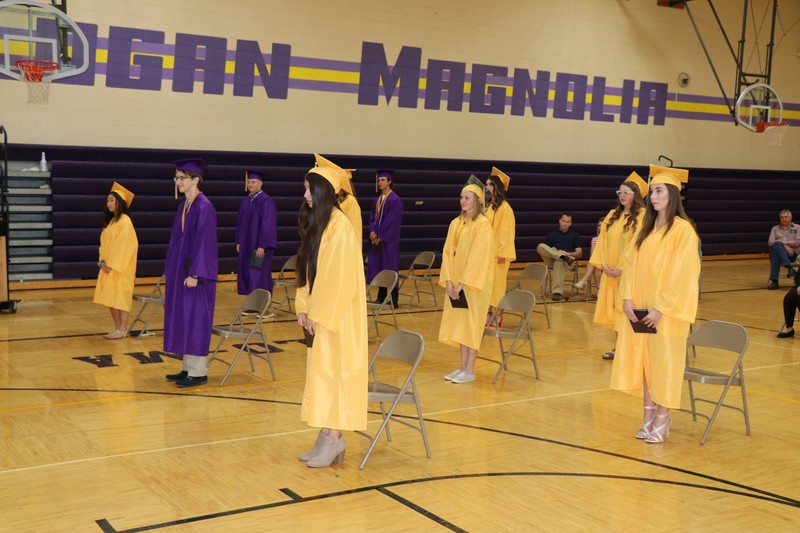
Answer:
top-left (295, 167), bottom-right (369, 467)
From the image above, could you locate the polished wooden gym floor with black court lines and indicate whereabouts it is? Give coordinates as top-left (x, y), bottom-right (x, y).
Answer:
top-left (0, 259), bottom-right (800, 532)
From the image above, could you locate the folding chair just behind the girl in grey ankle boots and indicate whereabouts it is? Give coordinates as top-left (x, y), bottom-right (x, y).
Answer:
top-left (356, 329), bottom-right (431, 469)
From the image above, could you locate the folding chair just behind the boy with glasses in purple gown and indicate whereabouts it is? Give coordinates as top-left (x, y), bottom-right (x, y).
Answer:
top-left (206, 289), bottom-right (275, 386)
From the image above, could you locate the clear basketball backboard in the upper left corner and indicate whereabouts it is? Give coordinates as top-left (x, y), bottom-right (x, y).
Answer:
top-left (0, 0), bottom-right (89, 81)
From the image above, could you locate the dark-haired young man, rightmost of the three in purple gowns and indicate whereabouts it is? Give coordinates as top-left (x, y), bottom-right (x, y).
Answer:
top-left (367, 170), bottom-right (403, 307)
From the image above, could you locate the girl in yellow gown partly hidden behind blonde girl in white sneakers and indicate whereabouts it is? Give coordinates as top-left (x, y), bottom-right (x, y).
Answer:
top-left (486, 167), bottom-right (517, 325)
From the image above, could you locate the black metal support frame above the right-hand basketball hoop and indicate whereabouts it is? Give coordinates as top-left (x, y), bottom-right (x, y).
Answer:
top-left (670, 0), bottom-right (778, 124)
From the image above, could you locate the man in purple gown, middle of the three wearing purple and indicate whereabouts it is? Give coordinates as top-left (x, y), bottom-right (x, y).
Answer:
top-left (236, 170), bottom-right (278, 294)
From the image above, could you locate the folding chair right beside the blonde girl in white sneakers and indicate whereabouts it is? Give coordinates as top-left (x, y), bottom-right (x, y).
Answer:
top-left (481, 290), bottom-right (539, 383)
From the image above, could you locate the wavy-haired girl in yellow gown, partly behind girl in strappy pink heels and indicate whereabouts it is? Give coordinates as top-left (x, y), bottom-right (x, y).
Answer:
top-left (592, 172), bottom-right (647, 359)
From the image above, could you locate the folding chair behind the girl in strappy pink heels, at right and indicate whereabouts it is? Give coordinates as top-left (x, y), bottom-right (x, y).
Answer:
top-left (683, 320), bottom-right (750, 444)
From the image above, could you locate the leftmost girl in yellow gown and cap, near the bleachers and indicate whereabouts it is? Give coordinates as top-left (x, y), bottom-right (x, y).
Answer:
top-left (94, 181), bottom-right (139, 339)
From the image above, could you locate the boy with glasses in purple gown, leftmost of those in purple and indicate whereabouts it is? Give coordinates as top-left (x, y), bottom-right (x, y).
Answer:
top-left (164, 159), bottom-right (219, 388)
